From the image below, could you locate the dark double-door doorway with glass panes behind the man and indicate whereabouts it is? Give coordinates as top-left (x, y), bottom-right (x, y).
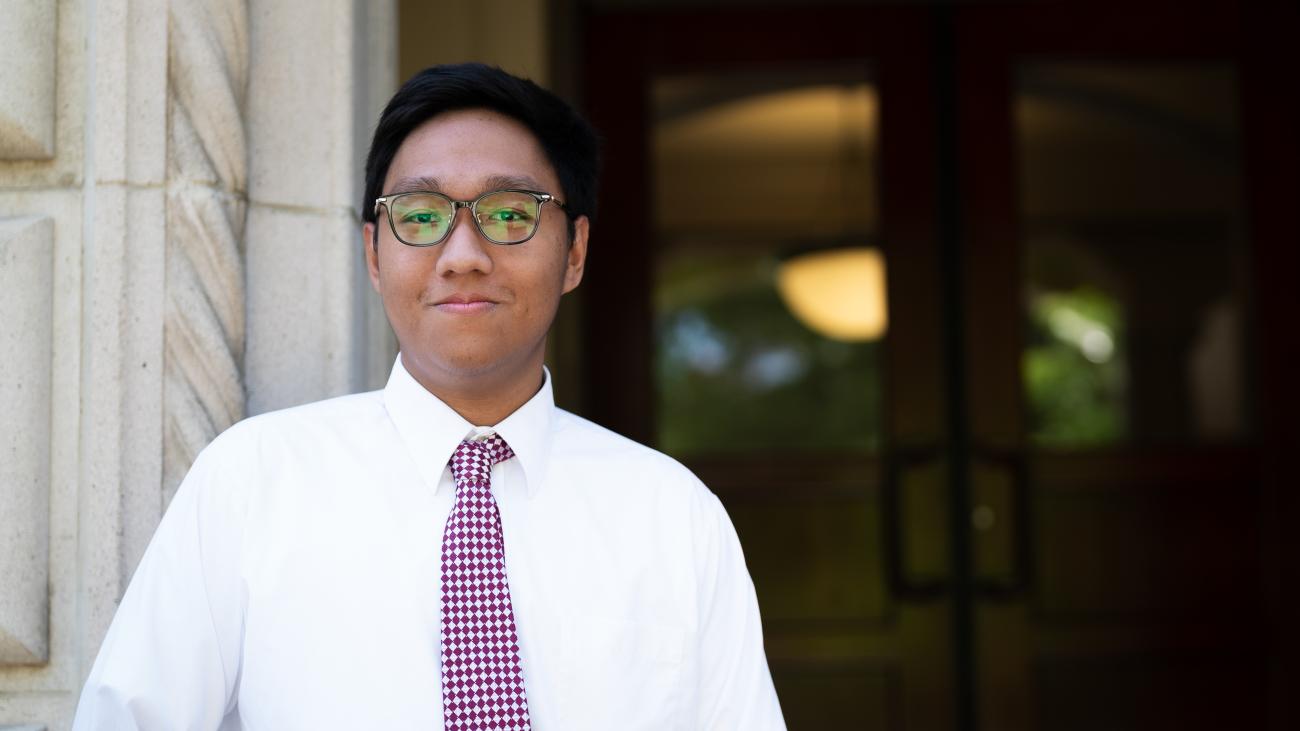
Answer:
top-left (584, 3), bottom-right (1295, 730)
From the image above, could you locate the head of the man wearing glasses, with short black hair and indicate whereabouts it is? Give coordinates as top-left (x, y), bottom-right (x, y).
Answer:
top-left (363, 64), bottom-right (597, 397)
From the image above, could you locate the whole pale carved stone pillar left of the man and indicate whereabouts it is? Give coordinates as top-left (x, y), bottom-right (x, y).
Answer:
top-left (0, 0), bottom-right (395, 731)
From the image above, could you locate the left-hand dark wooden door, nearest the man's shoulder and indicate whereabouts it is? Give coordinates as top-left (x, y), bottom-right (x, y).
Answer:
top-left (584, 7), bottom-right (957, 730)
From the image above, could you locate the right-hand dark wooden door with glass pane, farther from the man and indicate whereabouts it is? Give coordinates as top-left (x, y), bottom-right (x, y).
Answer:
top-left (953, 3), bottom-right (1295, 731)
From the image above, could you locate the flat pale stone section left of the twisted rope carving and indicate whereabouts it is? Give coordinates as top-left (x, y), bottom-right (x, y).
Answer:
top-left (0, 0), bottom-right (168, 730)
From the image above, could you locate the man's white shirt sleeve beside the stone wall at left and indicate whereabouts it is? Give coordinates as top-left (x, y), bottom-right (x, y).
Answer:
top-left (73, 438), bottom-right (246, 731)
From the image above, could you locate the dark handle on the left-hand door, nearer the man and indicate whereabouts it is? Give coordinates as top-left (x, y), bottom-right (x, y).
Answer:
top-left (881, 444), bottom-right (949, 601)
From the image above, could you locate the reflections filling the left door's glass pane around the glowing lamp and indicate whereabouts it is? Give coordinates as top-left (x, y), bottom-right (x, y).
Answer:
top-left (654, 70), bottom-right (880, 457)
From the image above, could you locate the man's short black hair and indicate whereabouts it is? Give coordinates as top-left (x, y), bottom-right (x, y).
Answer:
top-left (361, 64), bottom-right (601, 241)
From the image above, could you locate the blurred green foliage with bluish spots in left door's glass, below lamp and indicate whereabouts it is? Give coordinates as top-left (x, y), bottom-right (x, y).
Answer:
top-left (655, 254), bottom-right (880, 455)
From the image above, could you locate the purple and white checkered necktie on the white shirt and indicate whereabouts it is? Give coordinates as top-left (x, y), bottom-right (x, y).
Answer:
top-left (442, 434), bottom-right (532, 731)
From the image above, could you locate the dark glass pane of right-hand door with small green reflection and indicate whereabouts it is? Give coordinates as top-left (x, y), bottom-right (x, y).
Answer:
top-left (1015, 64), bottom-right (1248, 446)
